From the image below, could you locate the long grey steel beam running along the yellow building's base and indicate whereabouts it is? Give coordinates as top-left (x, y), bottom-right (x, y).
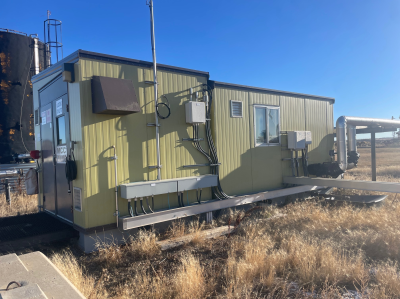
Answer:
top-left (119, 186), bottom-right (320, 230)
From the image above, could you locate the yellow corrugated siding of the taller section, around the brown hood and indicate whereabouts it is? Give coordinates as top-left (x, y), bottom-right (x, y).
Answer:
top-left (80, 59), bottom-right (211, 227)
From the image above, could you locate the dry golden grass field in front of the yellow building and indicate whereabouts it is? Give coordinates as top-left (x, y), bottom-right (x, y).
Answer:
top-left (0, 148), bottom-right (400, 298)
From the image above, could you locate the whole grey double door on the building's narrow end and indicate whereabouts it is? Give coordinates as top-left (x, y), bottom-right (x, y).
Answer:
top-left (39, 77), bottom-right (73, 222)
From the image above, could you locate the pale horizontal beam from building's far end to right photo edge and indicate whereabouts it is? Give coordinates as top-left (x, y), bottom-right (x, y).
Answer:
top-left (283, 177), bottom-right (400, 193)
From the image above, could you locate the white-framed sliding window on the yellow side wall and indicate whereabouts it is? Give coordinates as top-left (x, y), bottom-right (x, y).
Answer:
top-left (254, 105), bottom-right (280, 146)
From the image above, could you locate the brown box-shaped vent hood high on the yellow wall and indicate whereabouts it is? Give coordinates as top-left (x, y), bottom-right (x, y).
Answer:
top-left (92, 76), bottom-right (140, 115)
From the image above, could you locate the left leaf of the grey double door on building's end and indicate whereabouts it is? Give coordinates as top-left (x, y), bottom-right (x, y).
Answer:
top-left (40, 103), bottom-right (57, 214)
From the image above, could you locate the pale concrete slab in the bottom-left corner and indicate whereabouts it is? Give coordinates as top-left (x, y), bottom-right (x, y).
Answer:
top-left (0, 251), bottom-right (85, 299)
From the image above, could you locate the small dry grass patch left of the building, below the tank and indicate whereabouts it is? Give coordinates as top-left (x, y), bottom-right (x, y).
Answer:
top-left (0, 193), bottom-right (38, 218)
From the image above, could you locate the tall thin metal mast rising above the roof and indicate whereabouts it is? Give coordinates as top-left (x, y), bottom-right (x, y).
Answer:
top-left (149, 0), bottom-right (161, 180)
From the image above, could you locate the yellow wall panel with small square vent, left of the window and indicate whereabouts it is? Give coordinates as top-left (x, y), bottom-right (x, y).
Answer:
top-left (213, 87), bottom-right (253, 195)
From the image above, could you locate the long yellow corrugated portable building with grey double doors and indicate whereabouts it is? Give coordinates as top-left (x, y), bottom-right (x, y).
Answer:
top-left (32, 50), bottom-right (334, 251)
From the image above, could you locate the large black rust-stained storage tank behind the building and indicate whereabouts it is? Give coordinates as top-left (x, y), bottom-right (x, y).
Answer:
top-left (0, 29), bottom-right (46, 163)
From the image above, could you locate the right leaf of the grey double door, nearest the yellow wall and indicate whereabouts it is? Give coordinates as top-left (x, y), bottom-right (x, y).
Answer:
top-left (52, 94), bottom-right (73, 221)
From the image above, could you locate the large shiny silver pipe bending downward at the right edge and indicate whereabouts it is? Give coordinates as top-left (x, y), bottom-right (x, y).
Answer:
top-left (336, 116), bottom-right (400, 171)
